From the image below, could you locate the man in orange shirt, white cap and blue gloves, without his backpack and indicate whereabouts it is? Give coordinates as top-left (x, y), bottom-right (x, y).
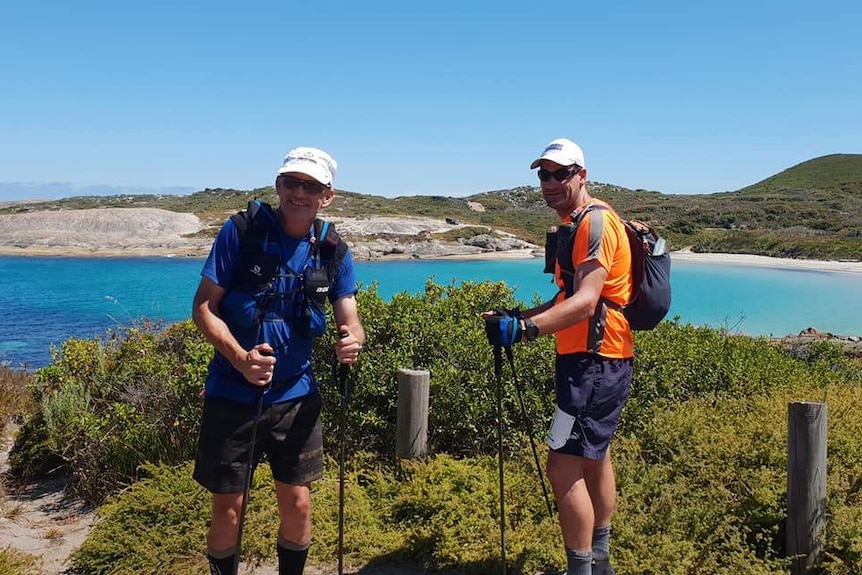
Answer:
top-left (489, 138), bottom-right (634, 575)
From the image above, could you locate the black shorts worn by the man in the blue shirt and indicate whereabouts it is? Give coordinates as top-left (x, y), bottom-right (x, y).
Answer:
top-left (194, 392), bottom-right (323, 493)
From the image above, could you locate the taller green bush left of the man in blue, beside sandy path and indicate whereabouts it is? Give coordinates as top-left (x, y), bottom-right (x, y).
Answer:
top-left (10, 322), bottom-right (212, 503)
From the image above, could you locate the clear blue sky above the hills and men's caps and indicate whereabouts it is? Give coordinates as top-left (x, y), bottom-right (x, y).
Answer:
top-left (0, 0), bottom-right (862, 200)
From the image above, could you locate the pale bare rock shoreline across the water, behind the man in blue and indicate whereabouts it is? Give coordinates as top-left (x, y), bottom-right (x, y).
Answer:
top-left (0, 208), bottom-right (539, 261)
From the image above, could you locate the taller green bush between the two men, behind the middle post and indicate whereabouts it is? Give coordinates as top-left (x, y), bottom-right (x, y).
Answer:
top-left (314, 278), bottom-right (553, 458)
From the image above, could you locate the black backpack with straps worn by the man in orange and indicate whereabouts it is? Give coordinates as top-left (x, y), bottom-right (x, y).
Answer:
top-left (545, 203), bottom-right (671, 331)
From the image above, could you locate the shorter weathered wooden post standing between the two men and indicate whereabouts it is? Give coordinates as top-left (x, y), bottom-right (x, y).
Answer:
top-left (395, 369), bottom-right (431, 459)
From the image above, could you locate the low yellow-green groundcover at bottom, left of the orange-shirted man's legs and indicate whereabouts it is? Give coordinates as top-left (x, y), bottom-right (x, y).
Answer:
top-left (73, 454), bottom-right (564, 575)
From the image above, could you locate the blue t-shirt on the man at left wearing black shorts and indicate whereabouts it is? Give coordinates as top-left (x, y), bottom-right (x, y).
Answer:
top-left (201, 209), bottom-right (357, 405)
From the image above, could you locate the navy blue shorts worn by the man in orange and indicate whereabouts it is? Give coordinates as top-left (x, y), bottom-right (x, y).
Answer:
top-left (549, 353), bottom-right (632, 460)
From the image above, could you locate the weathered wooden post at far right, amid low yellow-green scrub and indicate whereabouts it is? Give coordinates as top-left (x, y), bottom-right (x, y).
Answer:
top-left (787, 402), bottom-right (827, 575)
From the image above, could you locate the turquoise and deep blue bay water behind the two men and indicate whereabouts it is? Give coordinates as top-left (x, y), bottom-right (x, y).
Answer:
top-left (0, 257), bottom-right (862, 367)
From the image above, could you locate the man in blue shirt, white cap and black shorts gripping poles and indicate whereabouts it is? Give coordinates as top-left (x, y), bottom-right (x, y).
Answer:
top-left (192, 148), bottom-right (365, 575)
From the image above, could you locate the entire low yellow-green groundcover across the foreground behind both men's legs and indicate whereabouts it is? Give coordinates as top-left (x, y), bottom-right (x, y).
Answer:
top-left (75, 378), bottom-right (862, 575)
